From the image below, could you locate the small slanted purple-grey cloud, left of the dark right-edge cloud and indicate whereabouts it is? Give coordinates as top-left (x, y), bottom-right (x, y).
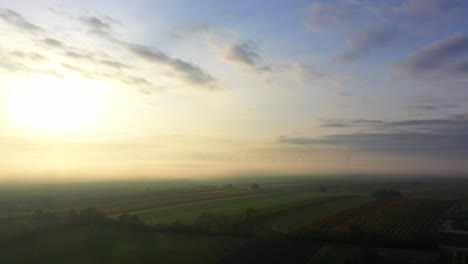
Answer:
top-left (338, 25), bottom-right (398, 61)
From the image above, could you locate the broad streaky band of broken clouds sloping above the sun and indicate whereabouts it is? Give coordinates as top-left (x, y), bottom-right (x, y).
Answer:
top-left (0, 9), bottom-right (219, 91)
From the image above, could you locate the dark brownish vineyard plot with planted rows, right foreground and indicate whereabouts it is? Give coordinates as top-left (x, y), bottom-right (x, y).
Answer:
top-left (303, 198), bottom-right (453, 246)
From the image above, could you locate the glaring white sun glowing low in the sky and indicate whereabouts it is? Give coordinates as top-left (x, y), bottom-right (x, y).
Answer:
top-left (6, 76), bottom-right (104, 133)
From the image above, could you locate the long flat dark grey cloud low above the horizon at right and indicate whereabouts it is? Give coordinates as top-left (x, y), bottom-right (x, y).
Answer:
top-left (277, 119), bottom-right (468, 158)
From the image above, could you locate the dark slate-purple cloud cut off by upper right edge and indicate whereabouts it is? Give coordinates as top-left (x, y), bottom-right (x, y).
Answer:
top-left (402, 33), bottom-right (468, 74)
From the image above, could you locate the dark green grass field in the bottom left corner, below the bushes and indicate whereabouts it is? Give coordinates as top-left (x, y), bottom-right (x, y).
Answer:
top-left (0, 226), bottom-right (245, 264)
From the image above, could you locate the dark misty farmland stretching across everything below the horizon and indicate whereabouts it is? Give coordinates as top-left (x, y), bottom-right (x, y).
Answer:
top-left (0, 177), bottom-right (468, 263)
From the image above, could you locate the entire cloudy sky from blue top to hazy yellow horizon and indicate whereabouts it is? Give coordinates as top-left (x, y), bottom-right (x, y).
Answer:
top-left (0, 0), bottom-right (468, 180)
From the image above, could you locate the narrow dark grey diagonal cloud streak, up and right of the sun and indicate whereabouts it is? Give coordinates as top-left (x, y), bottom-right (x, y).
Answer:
top-left (127, 45), bottom-right (216, 89)
